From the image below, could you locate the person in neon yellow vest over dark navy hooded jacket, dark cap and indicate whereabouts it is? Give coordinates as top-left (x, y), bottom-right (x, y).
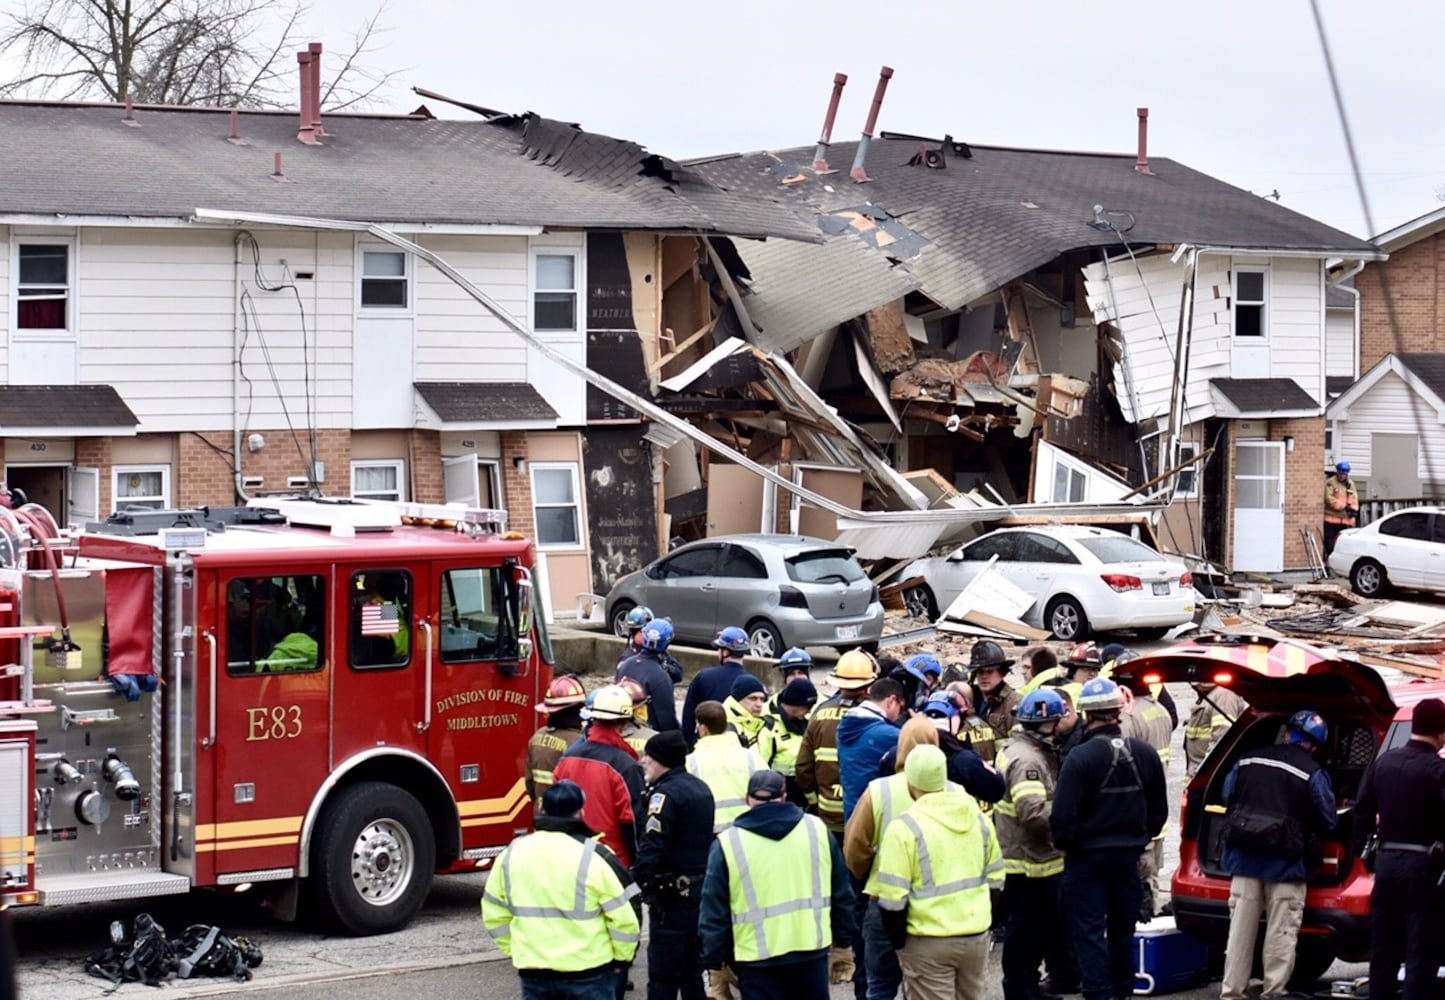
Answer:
top-left (699, 770), bottom-right (853, 1000)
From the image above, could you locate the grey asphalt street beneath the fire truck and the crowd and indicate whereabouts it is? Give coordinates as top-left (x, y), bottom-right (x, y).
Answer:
top-left (5, 685), bottom-right (1366, 1000)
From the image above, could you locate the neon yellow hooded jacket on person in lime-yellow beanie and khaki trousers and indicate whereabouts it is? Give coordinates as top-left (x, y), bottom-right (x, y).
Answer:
top-left (877, 792), bottom-right (1004, 938)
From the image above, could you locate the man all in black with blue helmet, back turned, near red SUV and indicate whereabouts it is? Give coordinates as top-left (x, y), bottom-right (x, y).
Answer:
top-left (1049, 678), bottom-right (1169, 1000)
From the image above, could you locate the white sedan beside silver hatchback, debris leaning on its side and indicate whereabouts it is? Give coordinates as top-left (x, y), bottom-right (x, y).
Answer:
top-left (899, 525), bottom-right (1195, 642)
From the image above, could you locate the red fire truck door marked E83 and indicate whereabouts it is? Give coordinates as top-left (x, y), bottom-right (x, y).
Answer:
top-left (203, 565), bottom-right (337, 874)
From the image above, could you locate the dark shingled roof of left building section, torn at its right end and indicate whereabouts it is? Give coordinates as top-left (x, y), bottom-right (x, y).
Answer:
top-left (0, 101), bottom-right (819, 240)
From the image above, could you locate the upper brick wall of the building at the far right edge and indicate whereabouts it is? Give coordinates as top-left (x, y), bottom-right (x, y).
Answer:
top-left (1355, 233), bottom-right (1445, 373)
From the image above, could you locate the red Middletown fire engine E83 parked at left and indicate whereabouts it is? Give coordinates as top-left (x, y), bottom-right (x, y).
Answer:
top-left (0, 499), bottom-right (552, 934)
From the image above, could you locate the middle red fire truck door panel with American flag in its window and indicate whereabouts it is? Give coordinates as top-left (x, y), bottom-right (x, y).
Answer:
top-left (331, 566), bottom-right (435, 767)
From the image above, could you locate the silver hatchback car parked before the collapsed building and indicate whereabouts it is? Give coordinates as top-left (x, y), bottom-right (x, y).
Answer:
top-left (607, 535), bottom-right (883, 659)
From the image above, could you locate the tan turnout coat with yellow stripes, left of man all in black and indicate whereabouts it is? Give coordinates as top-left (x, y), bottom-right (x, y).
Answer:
top-left (993, 731), bottom-right (1064, 879)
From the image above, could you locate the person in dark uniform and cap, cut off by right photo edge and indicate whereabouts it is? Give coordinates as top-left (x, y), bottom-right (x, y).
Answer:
top-left (1354, 698), bottom-right (1445, 1000)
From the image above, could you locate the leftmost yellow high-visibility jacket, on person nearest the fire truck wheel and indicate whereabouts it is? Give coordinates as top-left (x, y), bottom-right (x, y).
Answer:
top-left (481, 831), bottom-right (642, 973)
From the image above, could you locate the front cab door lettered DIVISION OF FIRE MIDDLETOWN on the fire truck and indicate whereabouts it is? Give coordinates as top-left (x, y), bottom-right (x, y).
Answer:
top-left (423, 565), bottom-right (538, 847)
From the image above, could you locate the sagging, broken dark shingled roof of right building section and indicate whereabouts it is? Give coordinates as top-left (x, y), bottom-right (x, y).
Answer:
top-left (691, 133), bottom-right (1379, 316)
